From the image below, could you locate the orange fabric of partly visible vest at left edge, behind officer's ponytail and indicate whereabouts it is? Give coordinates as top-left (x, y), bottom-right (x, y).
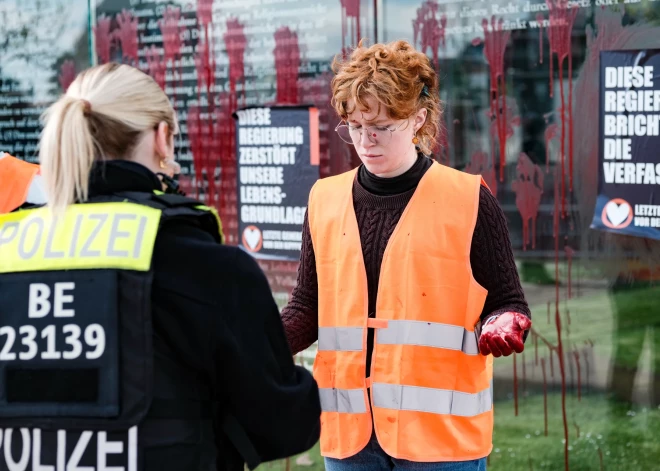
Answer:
top-left (0, 154), bottom-right (39, 214)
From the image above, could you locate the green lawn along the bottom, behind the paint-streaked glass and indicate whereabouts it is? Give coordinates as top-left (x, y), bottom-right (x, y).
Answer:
top-left (258, 394), bottom-right (660, 471)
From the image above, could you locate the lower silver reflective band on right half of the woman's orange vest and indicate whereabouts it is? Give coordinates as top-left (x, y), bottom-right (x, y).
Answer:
top-left (371, 383), bottom-right (493, 417)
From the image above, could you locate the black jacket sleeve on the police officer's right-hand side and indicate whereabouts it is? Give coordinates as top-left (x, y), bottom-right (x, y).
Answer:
top-left (155, 224), bottom-right (321, 461)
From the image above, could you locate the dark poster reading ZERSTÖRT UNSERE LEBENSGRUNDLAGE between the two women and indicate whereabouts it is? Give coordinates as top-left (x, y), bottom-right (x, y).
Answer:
top-left (234, 106), bottom-right (320, 261)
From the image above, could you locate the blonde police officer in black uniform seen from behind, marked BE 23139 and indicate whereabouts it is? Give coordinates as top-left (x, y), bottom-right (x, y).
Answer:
top-left (0, 64), bottom-right (320, 471)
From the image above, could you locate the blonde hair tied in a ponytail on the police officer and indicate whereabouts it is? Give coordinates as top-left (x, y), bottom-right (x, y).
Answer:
top-left (39, 63), bottom-right (177, 214)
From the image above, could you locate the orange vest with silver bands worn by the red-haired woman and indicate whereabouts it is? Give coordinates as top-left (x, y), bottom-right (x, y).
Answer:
top-left (308, 163), bottom-right (493, 462)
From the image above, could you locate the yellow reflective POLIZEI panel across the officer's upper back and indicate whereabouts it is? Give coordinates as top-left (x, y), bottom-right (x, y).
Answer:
top-left (0, 203), bottom-right (161, 273)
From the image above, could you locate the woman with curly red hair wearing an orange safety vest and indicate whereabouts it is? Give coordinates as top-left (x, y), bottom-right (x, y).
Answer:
top-left (282, 41), bottom-right (531, 471)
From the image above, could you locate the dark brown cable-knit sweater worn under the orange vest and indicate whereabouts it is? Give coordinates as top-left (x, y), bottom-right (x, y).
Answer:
top-left (282, 156), bottom-right (531, 365)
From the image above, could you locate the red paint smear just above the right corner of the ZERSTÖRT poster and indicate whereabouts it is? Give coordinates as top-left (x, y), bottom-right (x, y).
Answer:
top-left (273, 26), bottom-right (300, 104)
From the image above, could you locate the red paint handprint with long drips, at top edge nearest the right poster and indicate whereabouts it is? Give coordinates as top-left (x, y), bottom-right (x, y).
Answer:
top-left (546, 0), bottom-right (578, 217)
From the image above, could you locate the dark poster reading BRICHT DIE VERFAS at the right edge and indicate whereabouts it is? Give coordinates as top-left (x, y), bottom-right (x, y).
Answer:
top-left (591, 50), bottom-right (660, 239)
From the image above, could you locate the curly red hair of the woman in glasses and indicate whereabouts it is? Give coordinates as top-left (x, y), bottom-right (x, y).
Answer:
top-left (332, 40), bottom-right (442, 155)
